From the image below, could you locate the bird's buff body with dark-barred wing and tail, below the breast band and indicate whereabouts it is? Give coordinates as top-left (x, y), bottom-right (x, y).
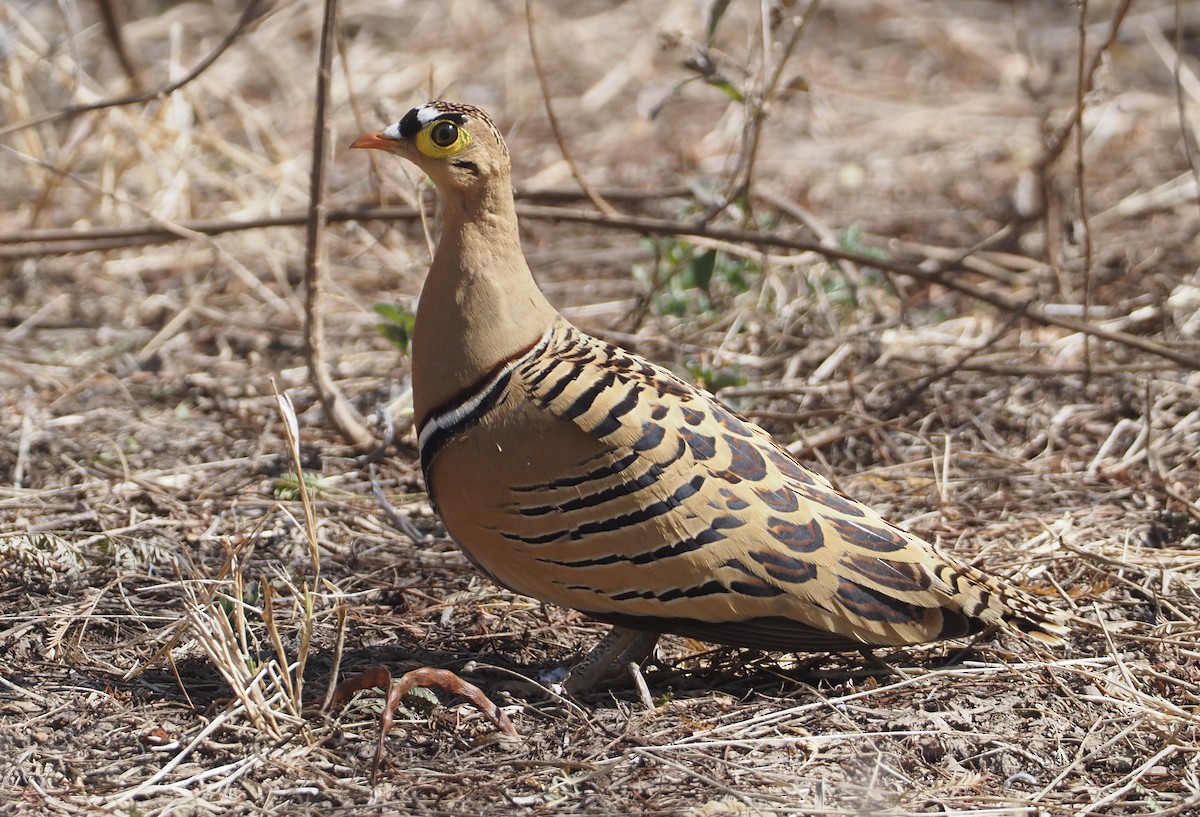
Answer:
top-left (427, 322), bottom-right (1061, 649)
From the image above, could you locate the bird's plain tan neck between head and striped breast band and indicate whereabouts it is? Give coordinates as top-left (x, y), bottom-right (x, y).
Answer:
top-left (413, 185), bottom-right (558, 423)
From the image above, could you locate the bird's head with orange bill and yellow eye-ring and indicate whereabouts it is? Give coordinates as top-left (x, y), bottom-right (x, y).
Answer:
top-left (350, 101), bottom-right (510, 193)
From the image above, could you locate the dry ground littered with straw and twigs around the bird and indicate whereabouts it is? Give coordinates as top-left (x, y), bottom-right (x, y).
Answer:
top-left (0, 0), bottom-right (1200, 817)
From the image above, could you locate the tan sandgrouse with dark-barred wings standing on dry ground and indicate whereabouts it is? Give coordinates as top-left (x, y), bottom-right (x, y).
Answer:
top-left (350, 101), bottom-right (1067, 692)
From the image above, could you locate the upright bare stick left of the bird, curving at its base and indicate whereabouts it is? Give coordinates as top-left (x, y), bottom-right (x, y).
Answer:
top-left (304, 0), bottom-right (376, 449)
